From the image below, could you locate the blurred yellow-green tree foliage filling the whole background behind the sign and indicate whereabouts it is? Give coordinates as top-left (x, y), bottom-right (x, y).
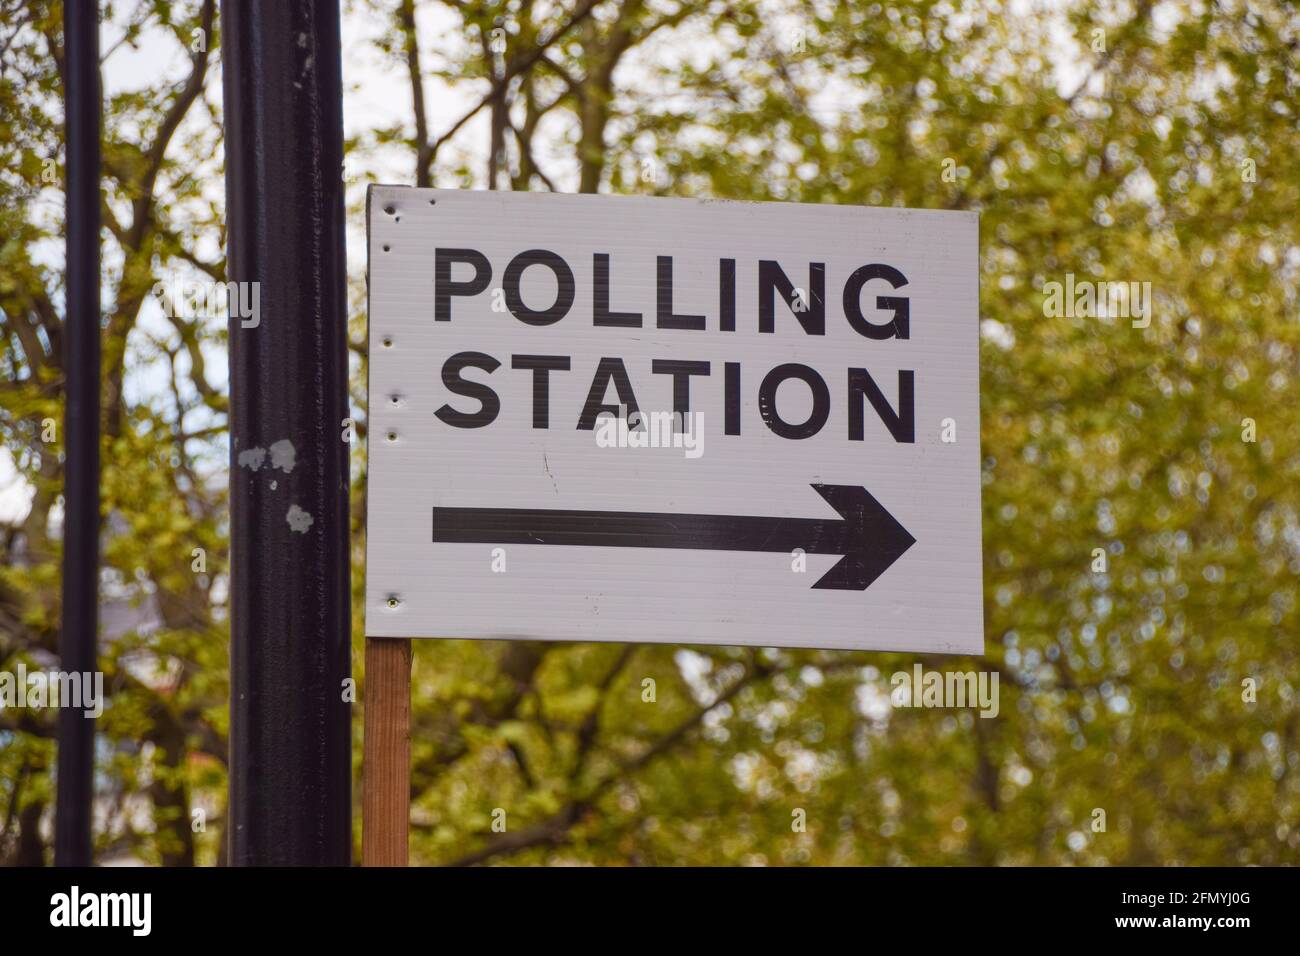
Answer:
top-left (0, 0), bottom-right (1300, 865)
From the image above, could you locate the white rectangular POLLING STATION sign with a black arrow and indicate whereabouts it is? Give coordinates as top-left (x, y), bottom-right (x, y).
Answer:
top-left (365, 186), bottom-right (983, 653)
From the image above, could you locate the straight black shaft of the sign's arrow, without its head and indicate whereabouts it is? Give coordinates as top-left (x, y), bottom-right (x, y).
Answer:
top-left (433, 507), bottom-right (848, 554)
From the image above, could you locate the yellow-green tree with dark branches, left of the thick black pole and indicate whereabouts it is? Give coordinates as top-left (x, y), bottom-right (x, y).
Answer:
top-left (0, 0), bottom-right (228, 865)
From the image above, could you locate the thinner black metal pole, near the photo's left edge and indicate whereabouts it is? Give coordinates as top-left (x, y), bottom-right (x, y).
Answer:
top-left (55, 0), bottom-right (100, 866)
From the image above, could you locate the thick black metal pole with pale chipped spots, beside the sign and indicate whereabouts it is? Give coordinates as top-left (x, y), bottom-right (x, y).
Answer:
top-left (221, 0), bottom-right (352, 865)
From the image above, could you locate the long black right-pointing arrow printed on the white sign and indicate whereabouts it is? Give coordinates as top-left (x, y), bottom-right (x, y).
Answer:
top-left (433, 485), bottom-right (917, 591)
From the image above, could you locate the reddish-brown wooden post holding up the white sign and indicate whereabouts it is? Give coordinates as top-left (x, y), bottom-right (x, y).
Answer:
top-left (361, 637), bottom-right (411, 866)
